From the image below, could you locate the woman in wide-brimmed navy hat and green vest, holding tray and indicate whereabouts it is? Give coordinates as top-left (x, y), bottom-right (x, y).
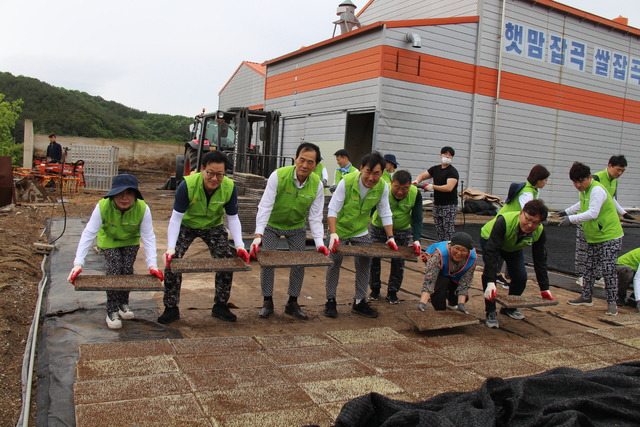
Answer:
top-left (67, 174), bottom-right (164, 329)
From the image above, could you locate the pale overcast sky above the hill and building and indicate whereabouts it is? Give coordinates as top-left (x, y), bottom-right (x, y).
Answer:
top-left (0, 0), bottom-right (640, 116)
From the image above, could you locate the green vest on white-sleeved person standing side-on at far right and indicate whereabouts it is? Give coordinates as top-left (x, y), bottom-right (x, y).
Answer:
top-left (580, 179), bottom-right (624, 243)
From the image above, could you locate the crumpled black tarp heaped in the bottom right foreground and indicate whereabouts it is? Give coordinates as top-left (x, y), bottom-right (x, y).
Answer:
top-left (335, 361), bottom-right (640, 427)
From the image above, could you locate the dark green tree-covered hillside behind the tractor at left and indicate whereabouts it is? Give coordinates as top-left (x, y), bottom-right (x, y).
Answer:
top-left (0, 72), bottom-right (193, 143)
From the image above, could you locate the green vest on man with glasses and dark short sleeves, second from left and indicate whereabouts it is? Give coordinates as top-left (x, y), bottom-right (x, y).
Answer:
top-left (182, 172), bottom-right (235, 230)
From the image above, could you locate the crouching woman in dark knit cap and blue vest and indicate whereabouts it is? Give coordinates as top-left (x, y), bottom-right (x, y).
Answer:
top-left (418, 232), bottom-right (477, 313)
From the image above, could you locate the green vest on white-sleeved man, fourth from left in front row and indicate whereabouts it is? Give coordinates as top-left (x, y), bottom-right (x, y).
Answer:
top-left (336, 172), bottom-right (387, 239)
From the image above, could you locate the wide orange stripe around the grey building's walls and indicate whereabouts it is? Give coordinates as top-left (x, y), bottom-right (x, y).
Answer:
top-left (265, 46), bottom-right (640, 124)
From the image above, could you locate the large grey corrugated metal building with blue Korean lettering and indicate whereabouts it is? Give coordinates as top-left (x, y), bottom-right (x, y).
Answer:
top-left (221, 0), bottom-right (640, 208)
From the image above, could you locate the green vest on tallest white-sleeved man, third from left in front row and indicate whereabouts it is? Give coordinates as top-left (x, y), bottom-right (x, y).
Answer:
top-left (267, 166), bottom-right (320, 230)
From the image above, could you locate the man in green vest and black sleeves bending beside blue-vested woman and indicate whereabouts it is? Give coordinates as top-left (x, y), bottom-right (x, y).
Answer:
top-left (480, 199), bottom-right (549, 328)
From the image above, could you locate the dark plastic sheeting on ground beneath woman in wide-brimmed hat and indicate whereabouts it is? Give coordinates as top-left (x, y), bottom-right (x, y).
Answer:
top-left (36, 218), bottom-right (181, 427)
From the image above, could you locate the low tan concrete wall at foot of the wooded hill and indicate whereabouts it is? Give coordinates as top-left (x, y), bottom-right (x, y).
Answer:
top-left (33, 134), bottom-right (184, 175)
